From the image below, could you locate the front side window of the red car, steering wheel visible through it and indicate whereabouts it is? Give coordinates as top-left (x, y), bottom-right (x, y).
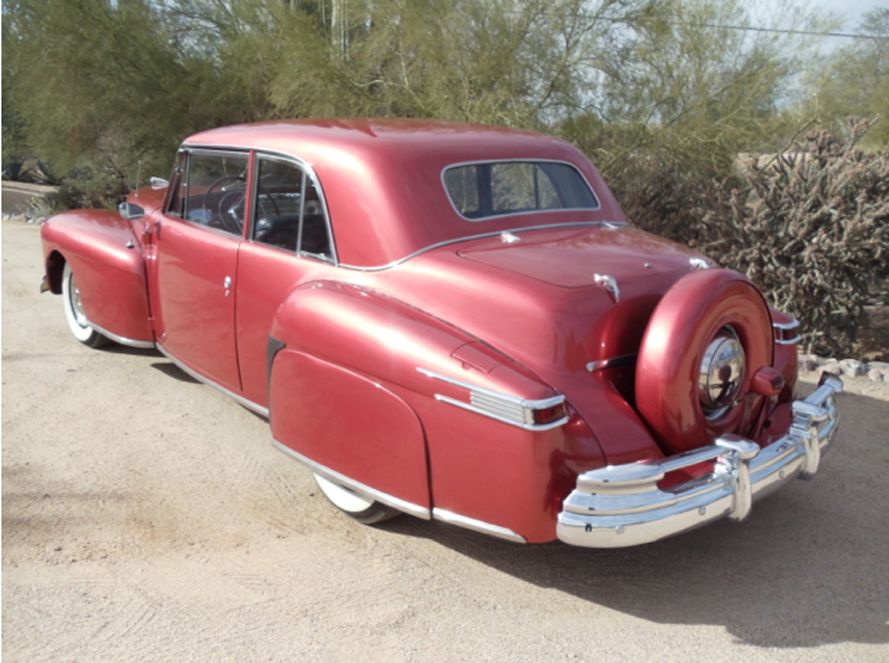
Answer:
top-left (183, 151), bottom-right (247, 235)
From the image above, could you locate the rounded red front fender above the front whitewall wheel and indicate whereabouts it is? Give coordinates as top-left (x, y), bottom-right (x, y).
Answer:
top-left (40, 210), bottom-right (153, 342)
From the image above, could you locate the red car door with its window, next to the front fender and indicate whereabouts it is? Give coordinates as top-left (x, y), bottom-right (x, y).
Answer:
top-left (149, 149), bottom-right (250, 394)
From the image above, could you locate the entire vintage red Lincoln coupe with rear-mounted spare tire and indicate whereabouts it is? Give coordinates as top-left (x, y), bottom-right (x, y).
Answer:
top-left (42, 120), bottom-right (842, 547)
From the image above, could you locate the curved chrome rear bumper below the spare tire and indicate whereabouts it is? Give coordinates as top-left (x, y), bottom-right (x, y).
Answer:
top-left (556, 374), bottom-right (843, 548)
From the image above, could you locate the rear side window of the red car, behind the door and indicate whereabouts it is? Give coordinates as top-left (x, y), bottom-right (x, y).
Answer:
top-left (253, 156), bottom-right (333, 260)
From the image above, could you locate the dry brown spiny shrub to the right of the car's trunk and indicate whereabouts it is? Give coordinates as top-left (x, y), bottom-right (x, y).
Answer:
top-left (698, 122), bottom-right (889, 354)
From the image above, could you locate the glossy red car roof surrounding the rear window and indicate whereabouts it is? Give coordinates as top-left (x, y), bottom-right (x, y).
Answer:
top-left (184, 119), bottom-right (623, 267)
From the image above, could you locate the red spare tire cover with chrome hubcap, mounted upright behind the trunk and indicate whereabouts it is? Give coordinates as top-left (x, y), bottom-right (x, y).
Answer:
top-left (635, 269), bottom-right (773, 452)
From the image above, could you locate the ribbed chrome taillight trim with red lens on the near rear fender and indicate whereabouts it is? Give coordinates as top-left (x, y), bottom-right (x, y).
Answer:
top-left (417, 366), bottom-right (568, 431)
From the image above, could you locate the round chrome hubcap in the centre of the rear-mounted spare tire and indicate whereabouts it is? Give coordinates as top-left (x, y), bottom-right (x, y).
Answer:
top-left (698, 327), bottom-right (745, 419)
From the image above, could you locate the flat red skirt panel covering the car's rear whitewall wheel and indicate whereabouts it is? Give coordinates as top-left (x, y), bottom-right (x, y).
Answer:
top-left (269, 347), bottom-right (431, 522)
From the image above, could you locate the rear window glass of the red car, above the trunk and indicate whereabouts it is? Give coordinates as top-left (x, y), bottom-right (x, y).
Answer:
top-left (444, 161), bottom-right (599, 221)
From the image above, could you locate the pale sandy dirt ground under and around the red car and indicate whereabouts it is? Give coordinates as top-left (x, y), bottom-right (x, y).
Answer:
top-left (2, 221), bottom-right (889, 662)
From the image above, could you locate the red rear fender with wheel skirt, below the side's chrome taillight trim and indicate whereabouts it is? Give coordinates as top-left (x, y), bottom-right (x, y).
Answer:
top-left (269, 282), bottom-right (601, 541)
